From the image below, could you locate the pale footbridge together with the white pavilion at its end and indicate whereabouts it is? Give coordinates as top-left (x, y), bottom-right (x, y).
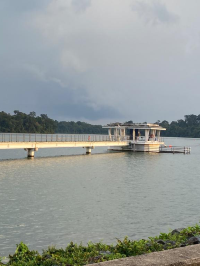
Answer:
top-left (0, 123), bottom-right (165, 157)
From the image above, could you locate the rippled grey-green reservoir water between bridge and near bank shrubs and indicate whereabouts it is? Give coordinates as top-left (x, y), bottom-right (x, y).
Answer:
top-left (0, 138), bottom-right (200, 256)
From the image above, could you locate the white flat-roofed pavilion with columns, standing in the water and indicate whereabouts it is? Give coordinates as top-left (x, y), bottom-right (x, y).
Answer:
top-left (104, 123), bottom-right (166, 152)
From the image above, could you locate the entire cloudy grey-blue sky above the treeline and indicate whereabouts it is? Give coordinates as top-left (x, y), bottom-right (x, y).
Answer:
top-left (0, 0), bottom-right (200, 124)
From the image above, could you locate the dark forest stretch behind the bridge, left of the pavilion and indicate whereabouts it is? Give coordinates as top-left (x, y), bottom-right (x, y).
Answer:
top-left (0, 110), bottom-right (107, 134)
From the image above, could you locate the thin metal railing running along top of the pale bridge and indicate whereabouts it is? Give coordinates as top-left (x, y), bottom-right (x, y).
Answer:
top-left (0, 133), bottom-right (129, 143)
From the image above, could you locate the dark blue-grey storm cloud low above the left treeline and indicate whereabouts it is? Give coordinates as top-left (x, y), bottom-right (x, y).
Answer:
top-left (0, 66), bottom-right (121, 121)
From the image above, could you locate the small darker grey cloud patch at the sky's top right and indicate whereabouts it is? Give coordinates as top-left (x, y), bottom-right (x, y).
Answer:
top-left (132, 1), bottom-right (178, 25)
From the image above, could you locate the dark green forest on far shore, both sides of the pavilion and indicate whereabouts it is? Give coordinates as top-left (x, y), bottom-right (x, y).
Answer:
top-left (0, 110), bottom-right (200, 138)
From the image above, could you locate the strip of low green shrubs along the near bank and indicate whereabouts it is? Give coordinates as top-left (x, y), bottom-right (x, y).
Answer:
top-left (0, 224), bottom-right (200, 266)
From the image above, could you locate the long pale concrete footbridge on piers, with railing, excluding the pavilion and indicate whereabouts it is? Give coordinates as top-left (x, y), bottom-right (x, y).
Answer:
top-left (0, 133), bottom-right (129, 157)
